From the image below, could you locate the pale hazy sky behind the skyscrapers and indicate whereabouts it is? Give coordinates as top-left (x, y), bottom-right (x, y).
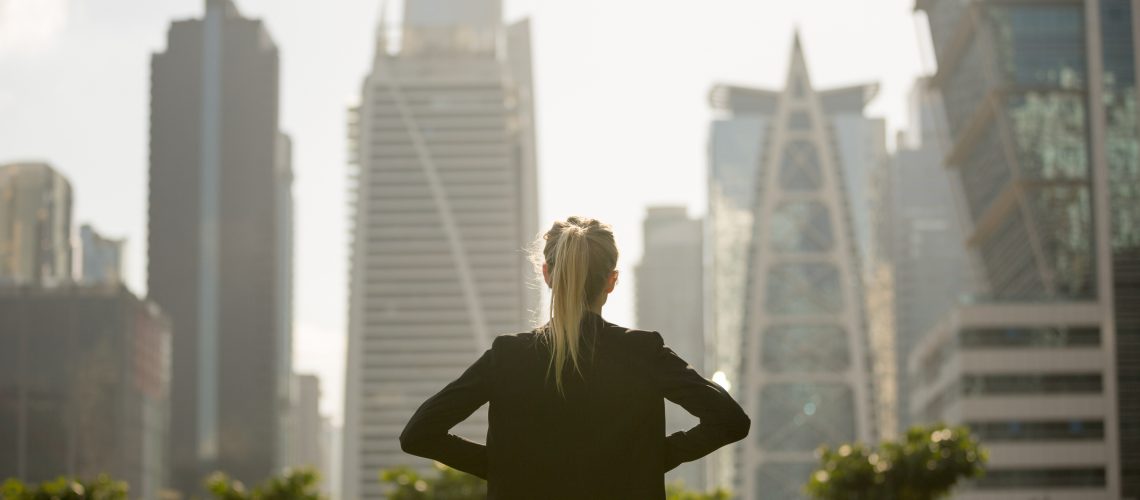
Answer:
top-left (0, 0), bottom-right (933, 421)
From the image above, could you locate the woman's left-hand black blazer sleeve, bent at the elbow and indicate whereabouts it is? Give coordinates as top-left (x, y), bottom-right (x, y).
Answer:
top-left (400, 343), bottom-right (495, 479)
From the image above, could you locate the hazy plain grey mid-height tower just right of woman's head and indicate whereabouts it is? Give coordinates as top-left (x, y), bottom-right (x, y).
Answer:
top-left (634, 206), bottom-right (708, 491)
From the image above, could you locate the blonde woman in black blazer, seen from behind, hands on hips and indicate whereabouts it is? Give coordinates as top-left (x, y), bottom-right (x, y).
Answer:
top-left (400, 218), bottom-right (750, 500)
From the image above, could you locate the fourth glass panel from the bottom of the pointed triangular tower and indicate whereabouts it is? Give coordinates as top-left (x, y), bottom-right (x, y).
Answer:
top-left (766, 262), bottom-right (844, 314)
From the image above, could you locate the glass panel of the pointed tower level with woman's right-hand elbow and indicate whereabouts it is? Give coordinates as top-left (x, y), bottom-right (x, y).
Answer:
top-left (756, 383), bottom-right (855, 451)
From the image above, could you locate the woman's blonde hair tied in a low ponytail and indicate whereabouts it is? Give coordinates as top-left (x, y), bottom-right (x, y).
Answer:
top-left (543, 216), bottom-right (618, 395)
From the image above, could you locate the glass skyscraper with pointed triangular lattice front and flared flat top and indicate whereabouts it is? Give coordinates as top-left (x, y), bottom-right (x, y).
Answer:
top-left (708, 38), bottom-right (881, 499)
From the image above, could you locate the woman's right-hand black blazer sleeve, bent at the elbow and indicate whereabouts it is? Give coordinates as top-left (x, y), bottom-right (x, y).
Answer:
top-left (653, 331), bottom-right (751, 472)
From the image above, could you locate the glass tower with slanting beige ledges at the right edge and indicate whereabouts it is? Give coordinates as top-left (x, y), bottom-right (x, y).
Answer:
top-left (918, 0), bottom-right (1140, 499)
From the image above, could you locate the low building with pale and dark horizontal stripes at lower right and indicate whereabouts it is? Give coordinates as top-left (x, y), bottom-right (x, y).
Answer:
top-left (905, 302), bottom-right (1118, 500)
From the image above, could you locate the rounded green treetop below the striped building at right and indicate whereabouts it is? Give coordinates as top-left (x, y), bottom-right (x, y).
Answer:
top-left (805, 425), bottom-right (986, 500)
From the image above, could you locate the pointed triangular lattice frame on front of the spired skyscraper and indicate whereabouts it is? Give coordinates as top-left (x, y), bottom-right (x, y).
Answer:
top-left (736, 36), bottom-right (876, 499)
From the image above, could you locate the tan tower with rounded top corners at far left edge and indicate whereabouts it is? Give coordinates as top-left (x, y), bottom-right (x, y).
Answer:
top-left (0, 163), bottom-right (72, 286)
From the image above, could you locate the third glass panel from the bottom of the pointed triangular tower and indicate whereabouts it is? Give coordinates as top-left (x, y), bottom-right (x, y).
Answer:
top-left (763, 325), bottom-right (850, 371)
